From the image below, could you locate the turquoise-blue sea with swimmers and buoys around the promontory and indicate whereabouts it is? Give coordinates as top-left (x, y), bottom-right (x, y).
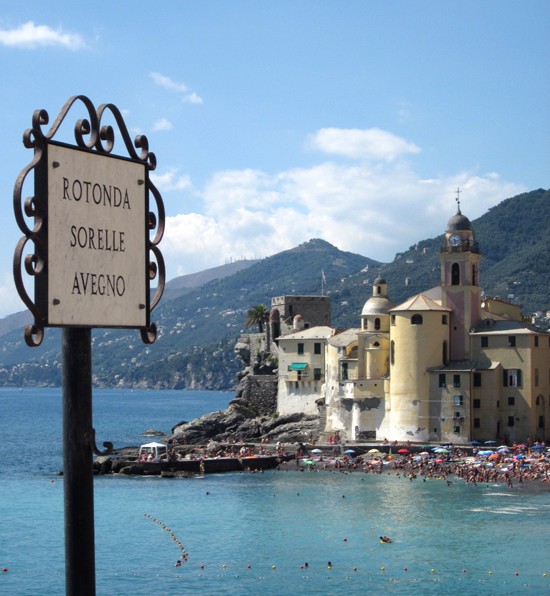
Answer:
top-left (0, 388), bottom-right (550, 596)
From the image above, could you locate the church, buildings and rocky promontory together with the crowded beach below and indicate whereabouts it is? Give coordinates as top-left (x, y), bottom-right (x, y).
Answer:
top-left (98, 205), bottom-right (550, 485)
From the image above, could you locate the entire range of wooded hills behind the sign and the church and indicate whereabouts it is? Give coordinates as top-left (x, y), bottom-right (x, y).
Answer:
top-left (0, 190), bottom-right (550, 389)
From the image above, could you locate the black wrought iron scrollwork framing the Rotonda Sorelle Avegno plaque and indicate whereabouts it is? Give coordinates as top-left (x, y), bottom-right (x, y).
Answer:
top-left (13, 95), bottom-right (166, 346)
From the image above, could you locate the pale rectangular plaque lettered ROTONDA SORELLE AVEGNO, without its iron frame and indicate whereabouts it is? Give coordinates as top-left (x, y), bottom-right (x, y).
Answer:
top-left (47, 143), bottom-right (148, 327)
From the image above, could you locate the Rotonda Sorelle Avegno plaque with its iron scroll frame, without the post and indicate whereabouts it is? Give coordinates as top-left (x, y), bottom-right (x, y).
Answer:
top-left (14, 95), bottom-right (165, 346)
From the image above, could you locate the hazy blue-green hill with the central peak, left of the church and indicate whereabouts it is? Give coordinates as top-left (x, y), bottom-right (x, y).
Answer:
top-left (0, 240), bottom-right (379, 389)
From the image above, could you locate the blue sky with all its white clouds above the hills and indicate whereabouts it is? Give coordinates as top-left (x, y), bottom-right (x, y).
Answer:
top-left (0, 0), bottom-right (550, 316)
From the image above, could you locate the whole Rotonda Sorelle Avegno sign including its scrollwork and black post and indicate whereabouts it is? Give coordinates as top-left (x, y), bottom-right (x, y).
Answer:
top-left (13, 95), bottom-right (165, 596)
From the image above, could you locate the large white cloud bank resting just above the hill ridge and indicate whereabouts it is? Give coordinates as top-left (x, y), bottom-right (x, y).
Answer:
top-left (161, 126), bottom-right (527, 279)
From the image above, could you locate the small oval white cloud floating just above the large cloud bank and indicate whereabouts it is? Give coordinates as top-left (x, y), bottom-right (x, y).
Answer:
top-left (310, 128), bottom-right (420, 161)
